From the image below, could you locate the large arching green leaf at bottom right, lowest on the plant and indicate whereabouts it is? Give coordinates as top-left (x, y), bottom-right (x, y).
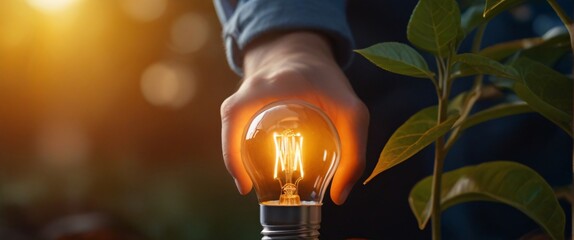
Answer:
top-left (409, 161), bottom-right (566, 239)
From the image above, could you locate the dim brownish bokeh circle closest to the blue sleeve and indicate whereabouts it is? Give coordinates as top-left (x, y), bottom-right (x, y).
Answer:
top-left (171, 12), bottom-right (210, 54)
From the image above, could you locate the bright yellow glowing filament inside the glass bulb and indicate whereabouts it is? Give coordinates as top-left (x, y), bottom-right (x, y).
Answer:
top-left (273, 130), bottom-right (304, 205)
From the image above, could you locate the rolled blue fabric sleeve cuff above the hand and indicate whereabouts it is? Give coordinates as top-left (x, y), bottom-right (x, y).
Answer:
top-left (214, 0), bottom-right (354, 75)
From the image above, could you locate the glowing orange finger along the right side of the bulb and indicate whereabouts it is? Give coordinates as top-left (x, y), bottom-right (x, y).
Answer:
top-left (331, 102), bottom-right (369, 205)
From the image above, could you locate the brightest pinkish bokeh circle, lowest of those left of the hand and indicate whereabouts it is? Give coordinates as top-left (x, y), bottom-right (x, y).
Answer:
top-left (141, 62), bottom-right (196, 108)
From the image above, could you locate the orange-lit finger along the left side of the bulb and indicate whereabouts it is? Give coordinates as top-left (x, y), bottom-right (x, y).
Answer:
top-left (221, 96), bottom-right (253, 195)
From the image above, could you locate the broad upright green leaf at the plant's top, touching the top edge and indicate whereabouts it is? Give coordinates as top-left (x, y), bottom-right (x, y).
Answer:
top-left (407, 0), bottom-right (460, 57)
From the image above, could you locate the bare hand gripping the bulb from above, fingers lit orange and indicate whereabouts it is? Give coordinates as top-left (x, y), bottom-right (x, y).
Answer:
top-left (221, 31), bottom-right (369, 205)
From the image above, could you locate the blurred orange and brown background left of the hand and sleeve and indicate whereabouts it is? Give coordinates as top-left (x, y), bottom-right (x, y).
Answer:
top-left (0, 0), bottom-right (260, 239)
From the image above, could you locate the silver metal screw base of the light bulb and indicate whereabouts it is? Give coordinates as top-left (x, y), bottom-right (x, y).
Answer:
top-left (259, 204), bottom-right (321, 240)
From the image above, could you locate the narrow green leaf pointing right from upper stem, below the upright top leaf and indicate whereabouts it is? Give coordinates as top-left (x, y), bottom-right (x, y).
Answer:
top-left (453, 53), bottom-right (519, 79)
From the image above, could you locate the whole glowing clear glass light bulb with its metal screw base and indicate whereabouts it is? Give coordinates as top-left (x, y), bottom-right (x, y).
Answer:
top-left (241, 100), bottom-right (341, 239)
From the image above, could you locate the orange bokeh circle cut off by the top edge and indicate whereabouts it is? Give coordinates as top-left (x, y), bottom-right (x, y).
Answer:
top-left (120, 0), bottom-right (167, 22)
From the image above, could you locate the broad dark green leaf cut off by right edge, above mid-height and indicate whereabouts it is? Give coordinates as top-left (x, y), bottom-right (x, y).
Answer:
top-left (512, 58), bottom-right (573, 136)
